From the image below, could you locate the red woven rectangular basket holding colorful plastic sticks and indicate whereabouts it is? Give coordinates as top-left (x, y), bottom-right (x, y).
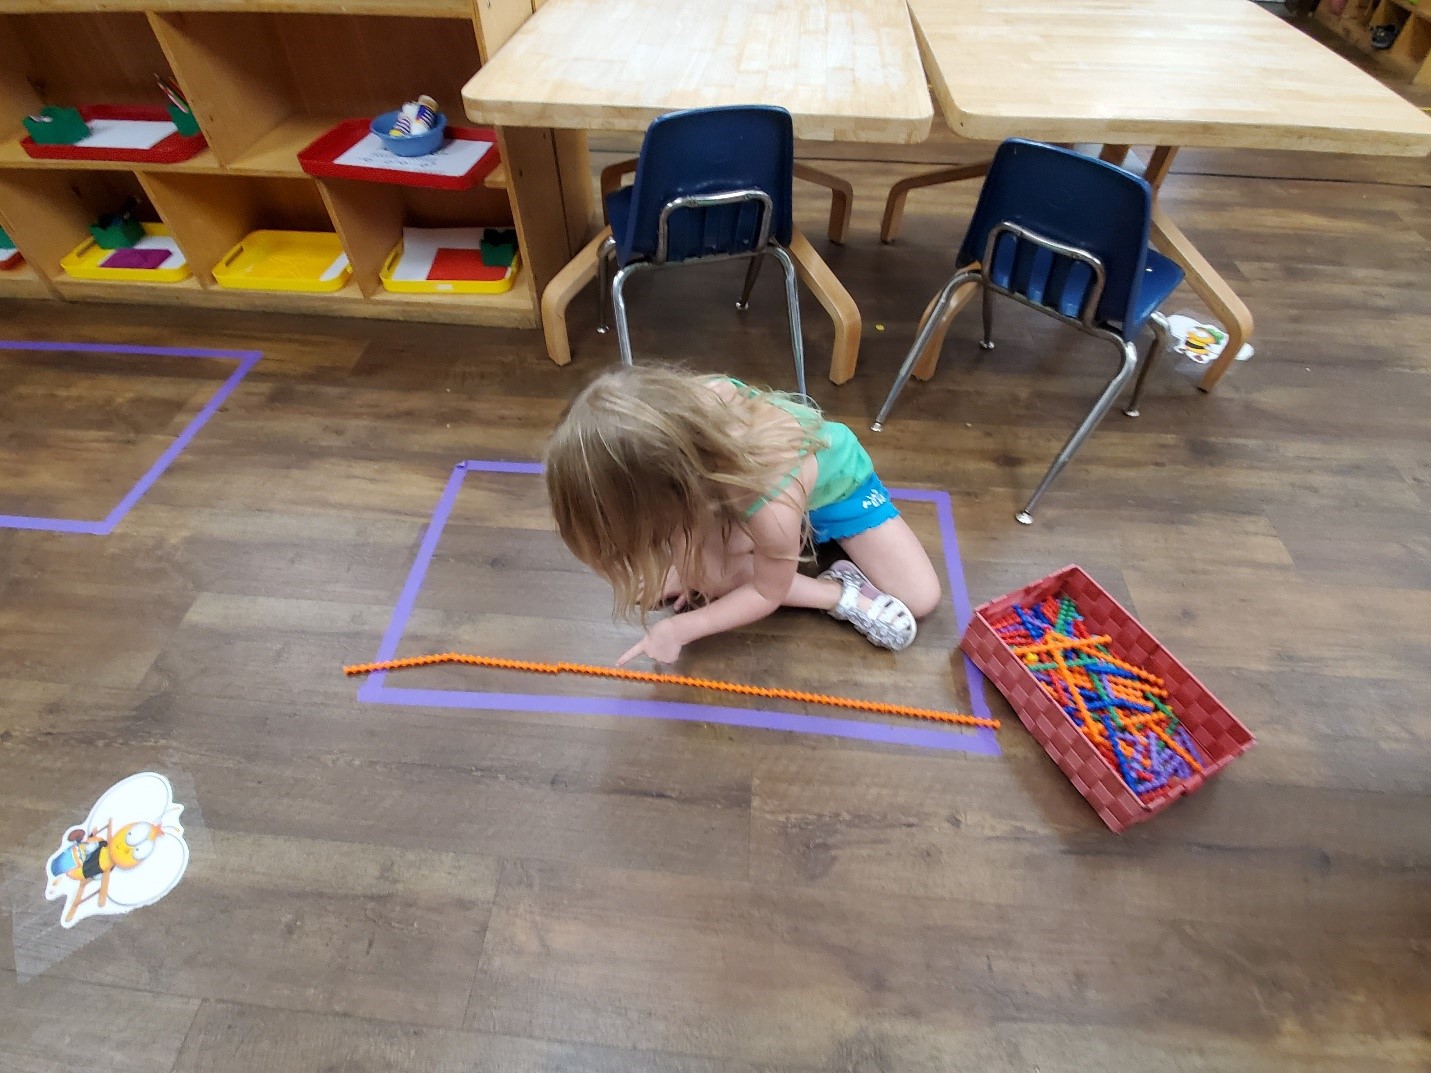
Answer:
top-left (959, 567), bottom-right (1256, 831)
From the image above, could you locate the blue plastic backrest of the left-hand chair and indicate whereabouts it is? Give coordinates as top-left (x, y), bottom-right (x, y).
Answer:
top-left (615, 104), bottom-right (796, 265)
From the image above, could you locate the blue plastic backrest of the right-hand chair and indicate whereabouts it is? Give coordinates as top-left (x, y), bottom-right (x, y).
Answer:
top-left (959, 139), bottom-right (1152, 328)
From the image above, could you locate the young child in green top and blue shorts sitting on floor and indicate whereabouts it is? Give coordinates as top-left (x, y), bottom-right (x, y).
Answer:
top-left (547, 365), bottom-right (940, 665)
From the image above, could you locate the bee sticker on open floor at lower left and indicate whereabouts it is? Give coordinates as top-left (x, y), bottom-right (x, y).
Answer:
top-left (44, 771), bottom-right (189, 927)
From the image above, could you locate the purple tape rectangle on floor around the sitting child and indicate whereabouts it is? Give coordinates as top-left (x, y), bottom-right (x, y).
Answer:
top-left (358, 459), bottom-right (999, 755)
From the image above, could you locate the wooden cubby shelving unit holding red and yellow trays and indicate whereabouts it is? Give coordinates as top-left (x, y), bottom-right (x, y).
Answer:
top-left (0, 0), bottom-right (591, 328)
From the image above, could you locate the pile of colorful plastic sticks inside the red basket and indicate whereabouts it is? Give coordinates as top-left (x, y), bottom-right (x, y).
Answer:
top-left (989, 592), bottom-right (1203, 797)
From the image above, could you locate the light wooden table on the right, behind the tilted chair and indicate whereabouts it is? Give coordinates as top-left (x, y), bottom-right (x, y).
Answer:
top-left (881, 0), bottom-right (1431, 389)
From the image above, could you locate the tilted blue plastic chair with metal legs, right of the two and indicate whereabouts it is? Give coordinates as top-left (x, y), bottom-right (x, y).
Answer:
top-left (870, 139), bottom-right (1182, 525)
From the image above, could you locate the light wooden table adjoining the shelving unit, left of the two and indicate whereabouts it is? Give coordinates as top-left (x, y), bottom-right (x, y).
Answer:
top-left (462, 0), bottom-right (934, 383)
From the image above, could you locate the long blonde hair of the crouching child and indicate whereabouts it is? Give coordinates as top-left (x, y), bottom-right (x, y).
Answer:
top-left (547, 366), bottom-right (826, 618)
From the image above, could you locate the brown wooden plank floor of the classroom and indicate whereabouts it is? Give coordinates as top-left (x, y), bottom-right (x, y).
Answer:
top-left (0, 29), bottom-right (1431, 1073)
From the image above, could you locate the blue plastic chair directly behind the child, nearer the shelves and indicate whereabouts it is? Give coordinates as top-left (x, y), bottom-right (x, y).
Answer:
top-left (597, 104), bottom-right (806, 395)
